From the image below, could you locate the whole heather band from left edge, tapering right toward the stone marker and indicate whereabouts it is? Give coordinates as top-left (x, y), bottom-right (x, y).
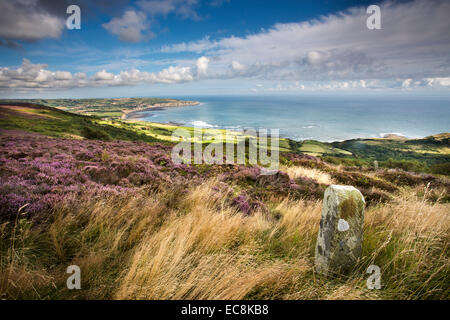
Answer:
top-left (0, 130), bottom-right (312, 220)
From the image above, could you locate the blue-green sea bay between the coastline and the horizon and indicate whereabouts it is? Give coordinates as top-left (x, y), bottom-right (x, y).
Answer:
top-left (133, 93), bottom-right (450, 142)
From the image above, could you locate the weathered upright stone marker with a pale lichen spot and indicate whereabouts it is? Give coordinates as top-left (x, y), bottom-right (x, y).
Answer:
top-left (315, 185), bottom-right (366, 275)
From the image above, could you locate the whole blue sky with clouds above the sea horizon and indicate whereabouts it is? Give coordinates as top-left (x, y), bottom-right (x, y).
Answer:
top-left (0, 0), bottom-right (450, 98)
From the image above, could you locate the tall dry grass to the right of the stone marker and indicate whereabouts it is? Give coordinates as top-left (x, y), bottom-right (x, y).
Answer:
top-left (363, 186), bottom-right (450, 299)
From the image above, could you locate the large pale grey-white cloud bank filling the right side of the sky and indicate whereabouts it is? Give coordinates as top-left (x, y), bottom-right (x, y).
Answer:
top-left (158, 0), bottom-right (450, 81)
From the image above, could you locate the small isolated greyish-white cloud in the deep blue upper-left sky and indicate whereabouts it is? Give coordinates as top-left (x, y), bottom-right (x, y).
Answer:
top-left (102, 10), bottom-right (153, 42)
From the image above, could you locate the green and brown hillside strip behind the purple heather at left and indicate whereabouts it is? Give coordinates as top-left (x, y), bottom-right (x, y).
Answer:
top-left (0, 102), bottom-right (290, 151)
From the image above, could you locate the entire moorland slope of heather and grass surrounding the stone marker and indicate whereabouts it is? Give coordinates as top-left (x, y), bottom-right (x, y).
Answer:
top-left (0, 104), bottom-right (450, 299)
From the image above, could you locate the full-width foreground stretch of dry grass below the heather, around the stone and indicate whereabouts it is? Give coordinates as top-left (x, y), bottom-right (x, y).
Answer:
top-left (0, 177), bottom-right (450, 299)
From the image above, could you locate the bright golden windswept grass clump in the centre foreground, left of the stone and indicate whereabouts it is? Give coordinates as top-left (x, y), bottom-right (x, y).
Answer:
top-left (116, 180), bottom-right (280, 299)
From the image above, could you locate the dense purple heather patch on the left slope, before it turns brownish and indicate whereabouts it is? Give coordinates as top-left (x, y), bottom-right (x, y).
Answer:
top-left (0, 131), bottom-right (196, 220)
